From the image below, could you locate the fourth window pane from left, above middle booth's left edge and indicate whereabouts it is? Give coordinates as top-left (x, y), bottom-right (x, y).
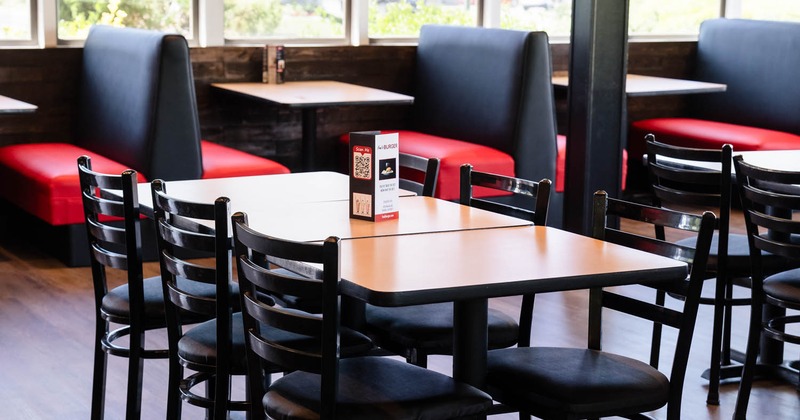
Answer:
top-left (367, 0), bottom-right (478, 38)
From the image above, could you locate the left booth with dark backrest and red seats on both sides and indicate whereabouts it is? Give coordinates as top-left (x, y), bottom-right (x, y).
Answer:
top-left (0, 26), bottom-right (289, 265)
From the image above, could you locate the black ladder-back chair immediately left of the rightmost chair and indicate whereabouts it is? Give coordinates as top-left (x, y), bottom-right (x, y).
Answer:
top-left (645, 134), bottom-right (789, 405)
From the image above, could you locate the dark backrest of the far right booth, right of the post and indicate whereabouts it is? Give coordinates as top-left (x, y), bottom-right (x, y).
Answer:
top-left (692, 19), bottom-right (800, 134)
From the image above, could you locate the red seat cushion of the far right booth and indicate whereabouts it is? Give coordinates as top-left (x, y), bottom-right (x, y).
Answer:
top-left (628, 118), bottom-right (800, 159)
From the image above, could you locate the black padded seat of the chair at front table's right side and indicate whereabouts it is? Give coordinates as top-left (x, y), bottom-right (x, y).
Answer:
top-left (486, 347), bottom-right (669, 417)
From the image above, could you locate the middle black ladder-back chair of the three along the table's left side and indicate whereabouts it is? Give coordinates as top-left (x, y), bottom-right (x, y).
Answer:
top-left (152, 179), bottom-right (250, 419)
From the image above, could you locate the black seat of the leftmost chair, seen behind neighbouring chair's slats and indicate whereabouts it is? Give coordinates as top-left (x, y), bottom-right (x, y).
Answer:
top-left (101, 277), bottom-right (230, 328)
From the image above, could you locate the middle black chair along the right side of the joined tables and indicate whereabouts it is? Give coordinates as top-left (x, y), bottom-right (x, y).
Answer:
top-left (364, 164), bottom-right (550, 367)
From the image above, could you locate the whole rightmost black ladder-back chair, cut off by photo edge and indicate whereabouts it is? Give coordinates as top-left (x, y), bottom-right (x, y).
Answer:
top-left (733, 156), bottom-right (800, 419)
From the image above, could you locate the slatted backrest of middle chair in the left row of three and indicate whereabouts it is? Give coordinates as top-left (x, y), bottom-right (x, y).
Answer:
top-left (151, 179), bottom-right (233, 352)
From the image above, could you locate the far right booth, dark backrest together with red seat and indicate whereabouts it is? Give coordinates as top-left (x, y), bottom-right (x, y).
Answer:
top-left (628, 19), bottom-right (800, 167)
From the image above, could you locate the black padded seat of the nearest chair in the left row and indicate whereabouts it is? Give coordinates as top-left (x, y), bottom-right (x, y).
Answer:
top-left (263, 357), bottom-right (491, 420)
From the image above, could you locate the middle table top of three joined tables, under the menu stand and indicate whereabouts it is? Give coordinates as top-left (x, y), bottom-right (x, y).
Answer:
top-left (242, 197), bottom-right (532, 241)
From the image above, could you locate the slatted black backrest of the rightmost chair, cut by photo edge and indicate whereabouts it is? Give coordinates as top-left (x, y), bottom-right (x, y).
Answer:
top-left (733, 156), bottom-right (800, 268)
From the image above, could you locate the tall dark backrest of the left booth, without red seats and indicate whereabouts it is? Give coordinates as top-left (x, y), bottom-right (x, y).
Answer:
top-left (75, 26), bottom-right (202, 180)
